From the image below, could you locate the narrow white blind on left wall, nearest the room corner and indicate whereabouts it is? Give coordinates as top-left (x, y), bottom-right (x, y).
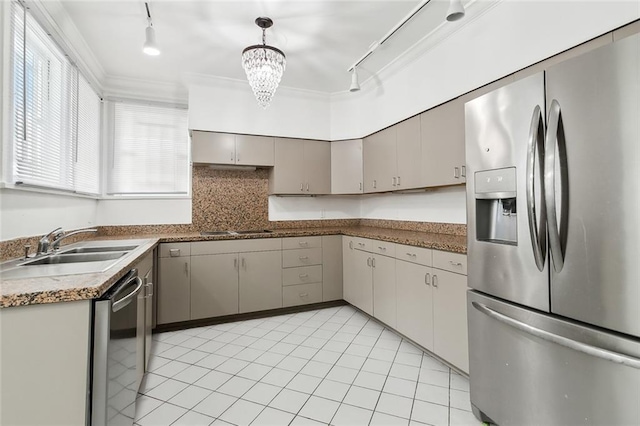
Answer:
top-left (74, 75), bottom-right (102, 194)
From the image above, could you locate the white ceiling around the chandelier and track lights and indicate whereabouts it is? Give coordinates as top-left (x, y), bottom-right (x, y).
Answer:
top-left (56, 0), bottom-right (460, 93)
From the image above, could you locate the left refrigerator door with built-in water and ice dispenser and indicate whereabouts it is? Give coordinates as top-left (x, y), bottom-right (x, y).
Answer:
top-left (465, 73), bottom-right (549, 312)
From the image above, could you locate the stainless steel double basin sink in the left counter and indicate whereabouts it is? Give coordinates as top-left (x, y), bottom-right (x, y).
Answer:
top-left (0, 241), bottom-right (140, 279)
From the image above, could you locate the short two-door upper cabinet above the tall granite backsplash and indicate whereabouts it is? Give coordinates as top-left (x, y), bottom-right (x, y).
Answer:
top-left (191, 130), bottom-right (274, 166)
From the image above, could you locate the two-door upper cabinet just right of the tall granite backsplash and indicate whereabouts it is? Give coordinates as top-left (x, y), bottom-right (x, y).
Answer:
top-left (269, 138), bottom-right (331, 195)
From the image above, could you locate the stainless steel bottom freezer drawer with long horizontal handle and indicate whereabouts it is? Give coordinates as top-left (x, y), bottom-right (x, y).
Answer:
top-left (467, 291), bottom-right (640, 426)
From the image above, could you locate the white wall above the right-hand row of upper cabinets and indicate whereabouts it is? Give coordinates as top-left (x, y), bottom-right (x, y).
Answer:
top-left (331, 0), bottom-right (640, 140)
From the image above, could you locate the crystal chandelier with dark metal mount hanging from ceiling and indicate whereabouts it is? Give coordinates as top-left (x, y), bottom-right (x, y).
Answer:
top-left (242, 18), bottom-right (287, 108)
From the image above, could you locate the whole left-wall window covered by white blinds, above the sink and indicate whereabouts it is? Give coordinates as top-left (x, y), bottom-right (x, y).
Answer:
top-left (8, 2), bottom-right (101, 194)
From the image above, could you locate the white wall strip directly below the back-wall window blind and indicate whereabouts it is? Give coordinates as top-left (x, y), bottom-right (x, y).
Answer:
top-left (96, 198), bottom-right (191, 226)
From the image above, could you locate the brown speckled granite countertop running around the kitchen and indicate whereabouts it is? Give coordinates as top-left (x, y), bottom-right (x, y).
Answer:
top-left (0, 226), bottom-right (467, 308)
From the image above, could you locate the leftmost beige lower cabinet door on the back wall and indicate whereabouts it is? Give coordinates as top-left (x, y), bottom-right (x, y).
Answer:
top-left (158, 256), bottom-right (191, 324)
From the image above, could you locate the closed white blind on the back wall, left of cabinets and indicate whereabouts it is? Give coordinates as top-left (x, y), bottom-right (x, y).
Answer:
top-left (107, 102), bottom-right (189, 195)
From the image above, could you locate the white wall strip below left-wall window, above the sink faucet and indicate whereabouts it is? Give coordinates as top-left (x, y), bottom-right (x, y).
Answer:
top-left (0, 188), bottom-right (98, 241)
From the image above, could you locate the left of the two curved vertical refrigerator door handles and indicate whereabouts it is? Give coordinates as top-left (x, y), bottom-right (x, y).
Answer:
top-left (526, 105), bottom-right (547, 271)
